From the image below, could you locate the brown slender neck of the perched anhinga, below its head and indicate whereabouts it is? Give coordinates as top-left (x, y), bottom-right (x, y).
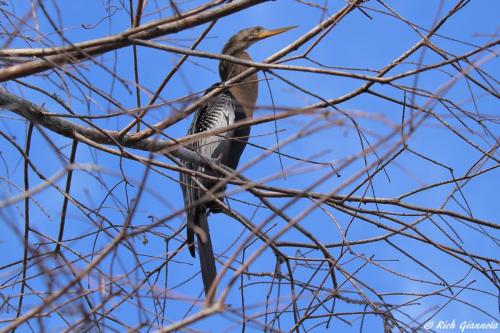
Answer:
top-left (219, 51), bottom-right (259, 118)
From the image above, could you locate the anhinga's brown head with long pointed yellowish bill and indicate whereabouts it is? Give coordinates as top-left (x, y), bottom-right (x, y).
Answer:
top-left (222, 26), bottom-right (295, 55)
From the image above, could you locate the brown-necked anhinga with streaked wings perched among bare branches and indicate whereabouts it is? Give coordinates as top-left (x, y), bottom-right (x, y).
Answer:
top-left (180, 27), bottom-right (293, 294)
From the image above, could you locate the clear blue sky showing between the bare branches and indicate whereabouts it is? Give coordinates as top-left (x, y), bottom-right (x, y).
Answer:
top-left (0, 0), bottom-right (500, 332)
